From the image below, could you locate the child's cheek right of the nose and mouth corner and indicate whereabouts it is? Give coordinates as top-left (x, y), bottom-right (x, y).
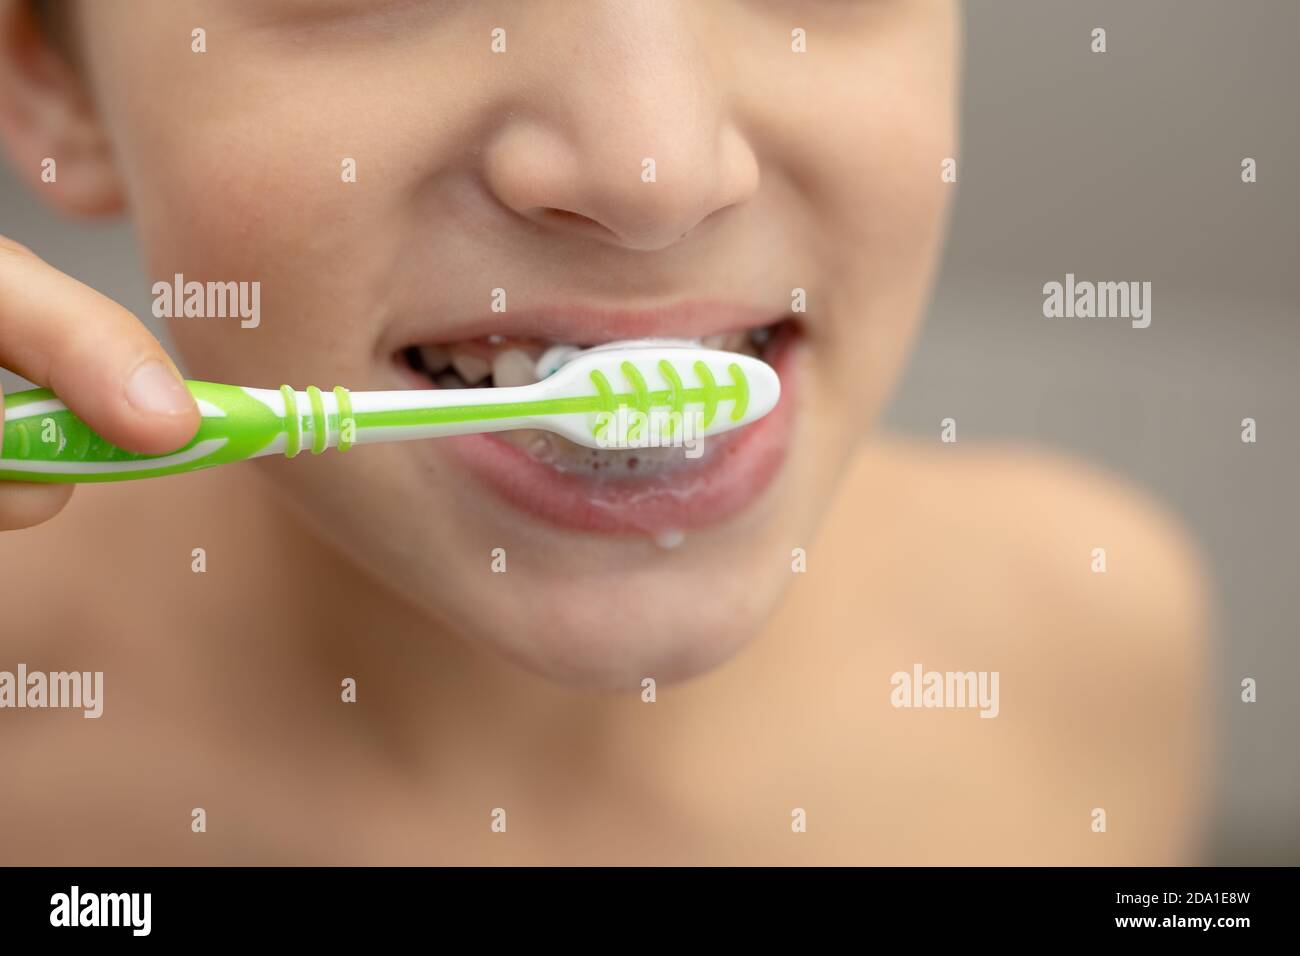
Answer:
top-left (746, 0), bottom-right (957, 438)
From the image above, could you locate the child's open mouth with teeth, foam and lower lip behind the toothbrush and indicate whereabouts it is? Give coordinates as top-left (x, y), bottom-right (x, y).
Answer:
top-left (394, 316), bottom-right (800, 540)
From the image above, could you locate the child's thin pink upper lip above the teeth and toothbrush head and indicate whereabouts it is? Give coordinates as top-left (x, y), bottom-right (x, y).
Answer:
top-left (384, 299), bottom-right (787, 350)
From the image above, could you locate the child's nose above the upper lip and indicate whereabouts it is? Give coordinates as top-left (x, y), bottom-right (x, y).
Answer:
top-left (484, 0), bottom-right (759, 251)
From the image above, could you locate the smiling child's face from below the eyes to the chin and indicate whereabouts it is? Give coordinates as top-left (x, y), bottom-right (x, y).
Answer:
top-left (81, 0), bottom-right (956, 684)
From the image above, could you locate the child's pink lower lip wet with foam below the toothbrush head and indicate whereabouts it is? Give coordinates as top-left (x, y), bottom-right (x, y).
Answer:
top-left (432, 337), bottom-right (800, 536)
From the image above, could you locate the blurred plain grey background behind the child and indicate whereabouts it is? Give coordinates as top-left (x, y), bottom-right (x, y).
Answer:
top-left (0, 0), bottom-right (1300, 864)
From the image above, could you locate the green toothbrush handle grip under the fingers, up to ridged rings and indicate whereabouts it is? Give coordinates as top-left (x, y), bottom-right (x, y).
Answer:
top-left (0, 381), bottom-right (355, 483)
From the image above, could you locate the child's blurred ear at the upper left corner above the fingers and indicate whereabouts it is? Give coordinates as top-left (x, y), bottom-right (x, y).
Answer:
top-left (0, 0), bottom-right (125, 216)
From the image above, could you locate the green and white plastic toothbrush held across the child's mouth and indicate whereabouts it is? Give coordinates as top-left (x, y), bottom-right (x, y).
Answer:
top-left (0, 342), bottom-right (780, 483)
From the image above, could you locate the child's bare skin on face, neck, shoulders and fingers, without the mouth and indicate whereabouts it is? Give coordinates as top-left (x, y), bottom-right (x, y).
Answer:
top-left (0, 0), bottom-right (1206, 862)
